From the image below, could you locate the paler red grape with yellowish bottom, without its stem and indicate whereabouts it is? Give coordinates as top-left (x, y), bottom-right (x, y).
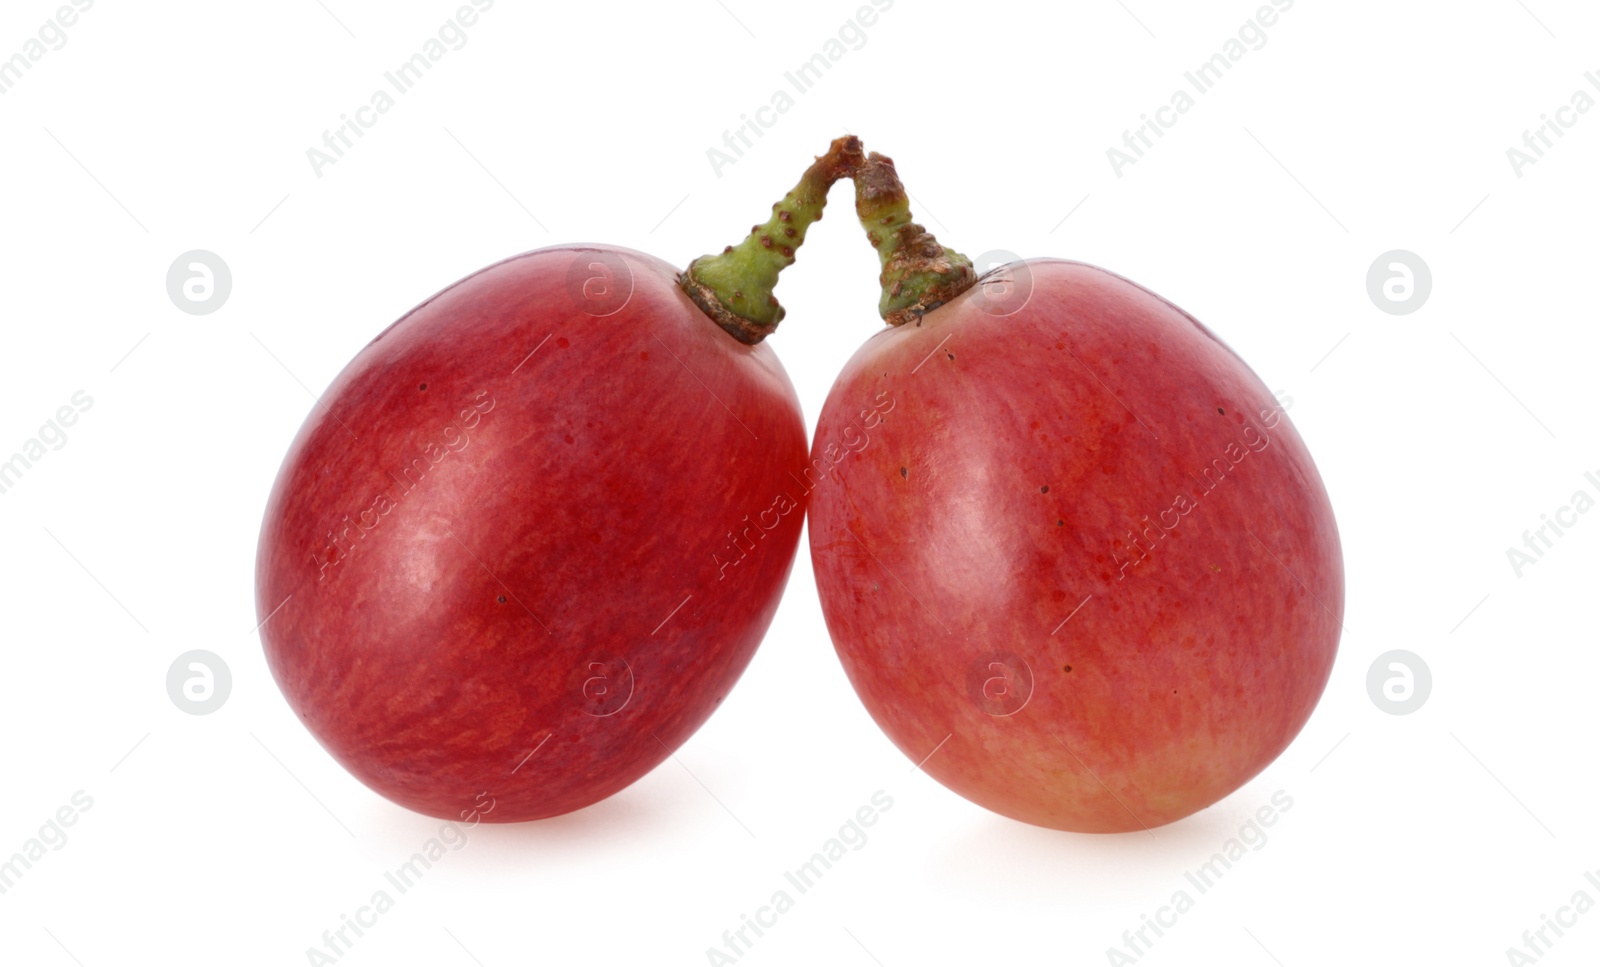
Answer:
top-left (810, 254), bottom-right (1344, 831)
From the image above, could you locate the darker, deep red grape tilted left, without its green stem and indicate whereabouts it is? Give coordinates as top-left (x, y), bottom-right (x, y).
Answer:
top-left (256, 247), bottom-right (806, 821)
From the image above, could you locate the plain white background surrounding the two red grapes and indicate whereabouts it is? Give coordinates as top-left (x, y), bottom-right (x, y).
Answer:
top-left (0, 0), bottom-right (1600, 967)
